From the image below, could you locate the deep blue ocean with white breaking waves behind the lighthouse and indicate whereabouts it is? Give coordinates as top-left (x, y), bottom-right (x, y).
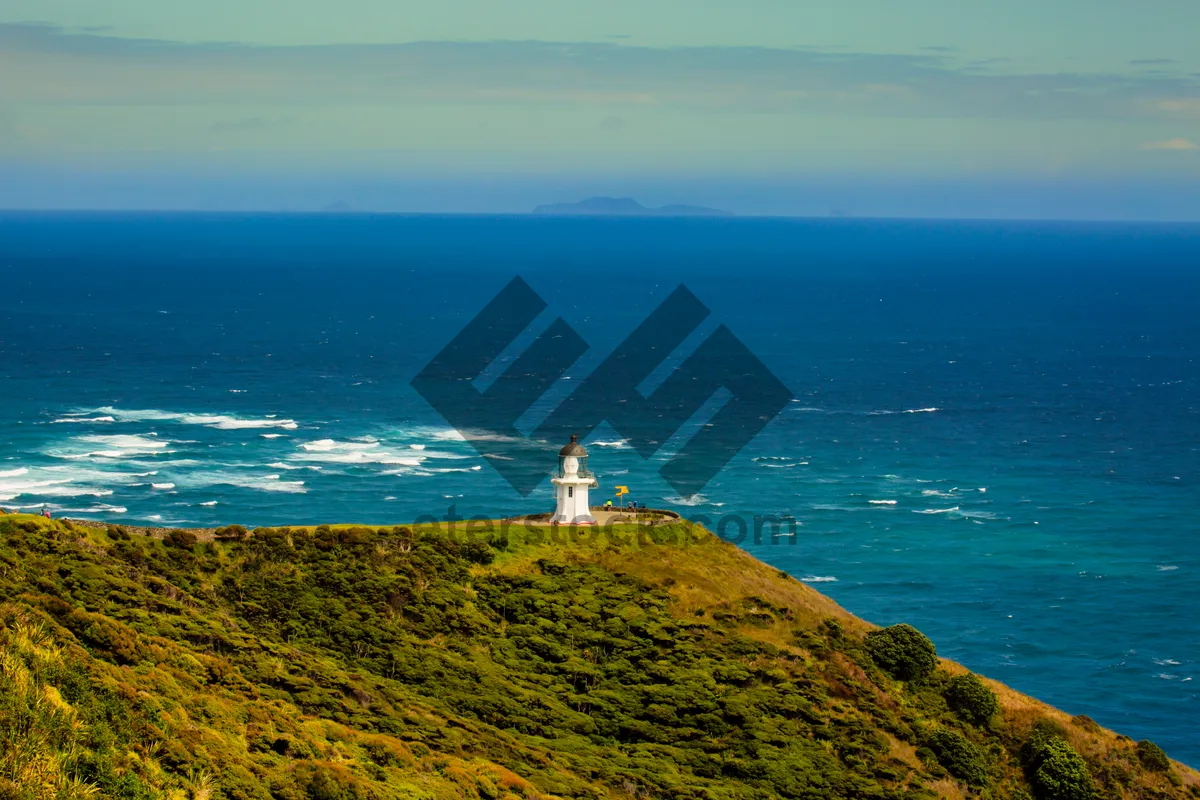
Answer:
top-left (0, 213), bottom-right (1200, 764)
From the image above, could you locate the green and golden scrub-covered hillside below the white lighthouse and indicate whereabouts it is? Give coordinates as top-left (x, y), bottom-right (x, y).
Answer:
top-left (0, 516), bottom-right (1200, 800)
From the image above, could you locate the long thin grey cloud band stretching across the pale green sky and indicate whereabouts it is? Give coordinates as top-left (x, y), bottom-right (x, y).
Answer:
top-left (0, 24), bottom-right (1200, 119)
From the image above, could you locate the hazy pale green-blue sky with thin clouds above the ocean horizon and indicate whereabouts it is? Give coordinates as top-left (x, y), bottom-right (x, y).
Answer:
top-left (0, 0), bottom-right (1200, 218)
